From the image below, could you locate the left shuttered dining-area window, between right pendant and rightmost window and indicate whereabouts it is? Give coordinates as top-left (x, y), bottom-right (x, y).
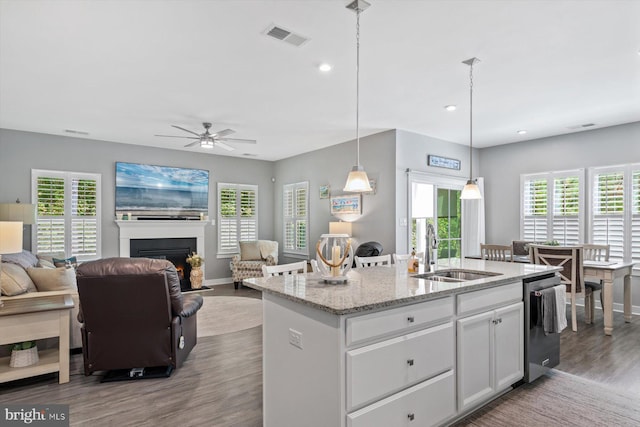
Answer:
top-left (520, 170), bottom-right (584, 245)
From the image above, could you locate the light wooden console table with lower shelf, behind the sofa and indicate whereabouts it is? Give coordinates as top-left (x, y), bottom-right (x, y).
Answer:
top-left (0, 291), bottom-right (73, 384)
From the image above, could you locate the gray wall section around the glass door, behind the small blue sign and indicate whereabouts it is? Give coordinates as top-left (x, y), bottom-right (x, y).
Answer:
top-left (395, 130), bottom-right (479, 253)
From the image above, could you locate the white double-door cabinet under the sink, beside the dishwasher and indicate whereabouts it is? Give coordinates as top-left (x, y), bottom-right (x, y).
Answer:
top-left (457, 302), bottom-right (524, 412)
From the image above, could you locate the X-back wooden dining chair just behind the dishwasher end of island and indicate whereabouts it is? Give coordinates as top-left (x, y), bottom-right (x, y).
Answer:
top-left (529, 244), bottom-right (587, 332)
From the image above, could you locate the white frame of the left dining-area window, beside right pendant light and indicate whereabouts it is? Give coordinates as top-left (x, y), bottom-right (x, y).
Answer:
top-left (520, 169), bottom-right (585, 245)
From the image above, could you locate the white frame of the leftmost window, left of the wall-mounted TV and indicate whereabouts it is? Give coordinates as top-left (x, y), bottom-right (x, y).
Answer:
top-left (31, 169), bottom-right (102, 261)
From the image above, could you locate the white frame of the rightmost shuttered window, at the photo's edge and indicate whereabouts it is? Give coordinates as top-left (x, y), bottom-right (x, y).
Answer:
top-left (587, 163), bottom-right (640, 269)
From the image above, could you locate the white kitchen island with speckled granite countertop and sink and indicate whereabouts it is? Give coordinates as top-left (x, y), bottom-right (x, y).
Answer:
top-left (244, 260), bottom-right (557, 427)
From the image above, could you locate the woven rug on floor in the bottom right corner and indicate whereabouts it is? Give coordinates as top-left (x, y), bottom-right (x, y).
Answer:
top-left (455, 370), bottom-right (640, 427)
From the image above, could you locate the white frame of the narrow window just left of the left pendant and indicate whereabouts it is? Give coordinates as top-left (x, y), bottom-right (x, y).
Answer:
top-left (282, 181), bottom-right (309, 258)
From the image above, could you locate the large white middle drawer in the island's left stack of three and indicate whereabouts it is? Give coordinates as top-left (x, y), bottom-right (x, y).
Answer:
top-left (347, 322), bottom-right (455, 411)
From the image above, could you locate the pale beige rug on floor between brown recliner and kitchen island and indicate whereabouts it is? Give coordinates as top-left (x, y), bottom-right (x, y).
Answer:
top-left (198, 296), bottom-right (262, 337)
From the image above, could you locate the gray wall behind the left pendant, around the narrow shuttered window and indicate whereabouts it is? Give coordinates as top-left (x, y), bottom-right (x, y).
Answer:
top-left (274, 130), bottom-right (395, 262)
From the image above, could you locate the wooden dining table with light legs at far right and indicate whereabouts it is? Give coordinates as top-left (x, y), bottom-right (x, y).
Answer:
top-left (584, 260), bottom-right (635, 335)
